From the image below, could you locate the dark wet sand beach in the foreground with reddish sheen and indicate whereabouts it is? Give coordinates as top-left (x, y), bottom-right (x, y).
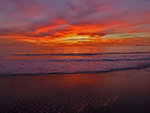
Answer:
top-left (0, 68), bottom-right (150, 113)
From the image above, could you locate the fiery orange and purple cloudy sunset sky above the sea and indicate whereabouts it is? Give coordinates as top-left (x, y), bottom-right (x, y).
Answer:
top-left (0, 0), bottom-right (150, 45)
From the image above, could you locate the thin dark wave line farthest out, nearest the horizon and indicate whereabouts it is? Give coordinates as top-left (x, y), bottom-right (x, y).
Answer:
top-left (12, 51), bottom-right (150, 56)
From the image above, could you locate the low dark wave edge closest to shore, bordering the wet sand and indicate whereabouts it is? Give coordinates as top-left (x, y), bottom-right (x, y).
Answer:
top-left (0, 64), bottom-right (150, 77)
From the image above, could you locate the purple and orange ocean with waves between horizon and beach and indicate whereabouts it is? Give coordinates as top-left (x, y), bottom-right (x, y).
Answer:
top-left (0, 46), bottom-right (150, 76)
